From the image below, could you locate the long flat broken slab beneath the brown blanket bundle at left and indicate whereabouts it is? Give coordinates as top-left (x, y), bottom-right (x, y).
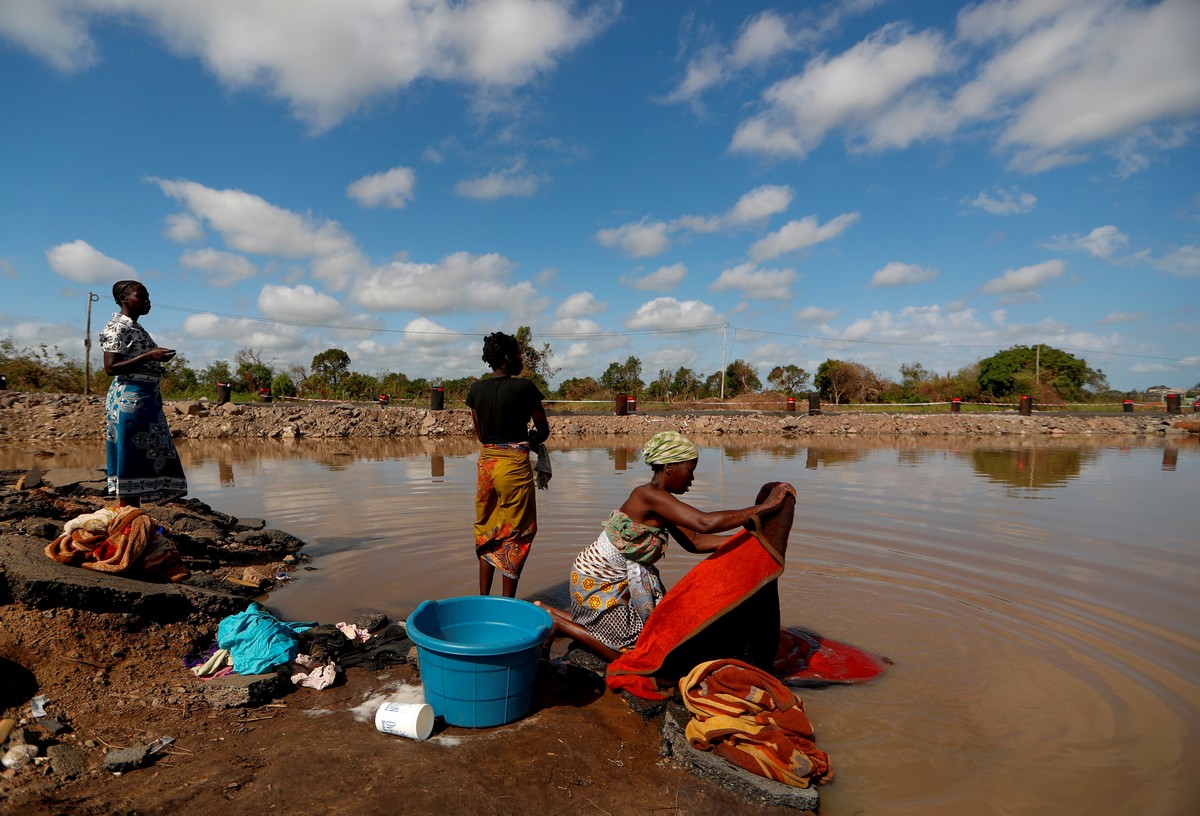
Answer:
top-left (0, 534), bottom-right (247, 620)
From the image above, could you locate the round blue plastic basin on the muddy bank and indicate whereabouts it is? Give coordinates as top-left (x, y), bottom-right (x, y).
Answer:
top-left (406, 595), bottom-right (553, 728)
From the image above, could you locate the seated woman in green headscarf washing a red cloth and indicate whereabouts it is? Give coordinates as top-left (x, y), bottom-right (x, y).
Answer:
top-left (539, 431), bottom-right (794, 660)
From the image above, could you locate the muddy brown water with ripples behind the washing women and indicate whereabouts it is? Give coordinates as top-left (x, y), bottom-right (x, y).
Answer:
top-left (0, 437), bottom-right (1200, 816)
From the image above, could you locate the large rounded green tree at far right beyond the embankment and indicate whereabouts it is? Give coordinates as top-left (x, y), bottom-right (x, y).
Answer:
top-left (979, 344), bottom-right (1108, 402)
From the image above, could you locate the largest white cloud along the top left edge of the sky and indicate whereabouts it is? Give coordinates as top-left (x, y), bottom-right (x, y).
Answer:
top-left (9, 0), bottom-right (613, 131)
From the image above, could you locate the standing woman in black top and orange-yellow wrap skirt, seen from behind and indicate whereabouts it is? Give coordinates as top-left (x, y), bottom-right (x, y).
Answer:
top-left (467, 331), bottom-right (550, 598)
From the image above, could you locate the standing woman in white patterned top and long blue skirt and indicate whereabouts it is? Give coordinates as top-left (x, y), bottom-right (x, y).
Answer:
top-left (100, 281), bottom-right (187, 506)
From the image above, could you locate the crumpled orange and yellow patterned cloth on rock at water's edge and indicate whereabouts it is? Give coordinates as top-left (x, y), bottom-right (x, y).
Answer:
top-left (679, 660), bottom-right (833, 787)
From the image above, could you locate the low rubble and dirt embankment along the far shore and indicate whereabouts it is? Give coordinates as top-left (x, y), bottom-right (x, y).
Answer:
top-left (0, 392), bottom-right (1200, 443)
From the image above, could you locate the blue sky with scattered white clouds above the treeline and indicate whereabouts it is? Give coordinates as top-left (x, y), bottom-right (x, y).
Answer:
top-left (0, 0), bottom-right (1200, 389)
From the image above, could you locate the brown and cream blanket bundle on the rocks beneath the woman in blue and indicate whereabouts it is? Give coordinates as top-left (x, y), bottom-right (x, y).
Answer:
top-left (46, 506), bottom-right (191, 582)
